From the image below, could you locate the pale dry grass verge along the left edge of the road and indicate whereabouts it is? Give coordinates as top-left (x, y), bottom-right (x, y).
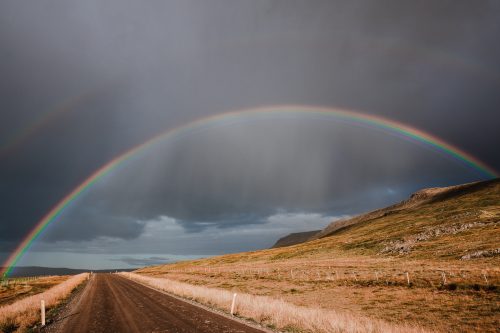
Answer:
top-left (0, 273), bottom-right (88, 332)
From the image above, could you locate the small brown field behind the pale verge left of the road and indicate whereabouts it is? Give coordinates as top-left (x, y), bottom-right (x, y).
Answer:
top-left (0, 275), bottom-right (69, 306)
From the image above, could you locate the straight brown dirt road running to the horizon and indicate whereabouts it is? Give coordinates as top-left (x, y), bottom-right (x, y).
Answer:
top-left (52, 274), bottom-right (264, 333)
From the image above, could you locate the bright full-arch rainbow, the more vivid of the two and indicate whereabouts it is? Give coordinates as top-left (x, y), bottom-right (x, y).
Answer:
top-left (0, 105), bottom-right (498, 277)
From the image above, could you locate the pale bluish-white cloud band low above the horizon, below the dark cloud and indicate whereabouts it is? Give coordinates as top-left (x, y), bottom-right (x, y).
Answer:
top-left (33, 211), bottom-right (346, 261)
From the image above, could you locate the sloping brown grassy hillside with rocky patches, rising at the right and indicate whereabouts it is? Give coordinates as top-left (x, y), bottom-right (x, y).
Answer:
top-left (305, 180), bottom-right (500, 260)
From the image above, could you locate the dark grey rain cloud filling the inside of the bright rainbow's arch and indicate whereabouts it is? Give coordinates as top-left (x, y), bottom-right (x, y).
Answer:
top-left (55, 116), bottom-right (484, 236)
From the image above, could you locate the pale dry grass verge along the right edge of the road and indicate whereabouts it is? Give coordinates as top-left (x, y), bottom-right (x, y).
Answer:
top-left (120, 273), bottom-right (425, 333)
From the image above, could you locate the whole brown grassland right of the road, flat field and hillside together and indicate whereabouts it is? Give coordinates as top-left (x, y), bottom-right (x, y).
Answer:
top-left (138, 180), bottom-right (500, 332)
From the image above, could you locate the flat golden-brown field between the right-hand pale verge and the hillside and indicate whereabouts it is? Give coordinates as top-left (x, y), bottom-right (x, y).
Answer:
top-left (140, 257), bottom-right (500, 332)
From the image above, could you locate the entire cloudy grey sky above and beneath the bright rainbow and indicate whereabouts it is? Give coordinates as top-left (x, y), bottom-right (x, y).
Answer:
top-left (0, 0), bottom-right (500, 269)
